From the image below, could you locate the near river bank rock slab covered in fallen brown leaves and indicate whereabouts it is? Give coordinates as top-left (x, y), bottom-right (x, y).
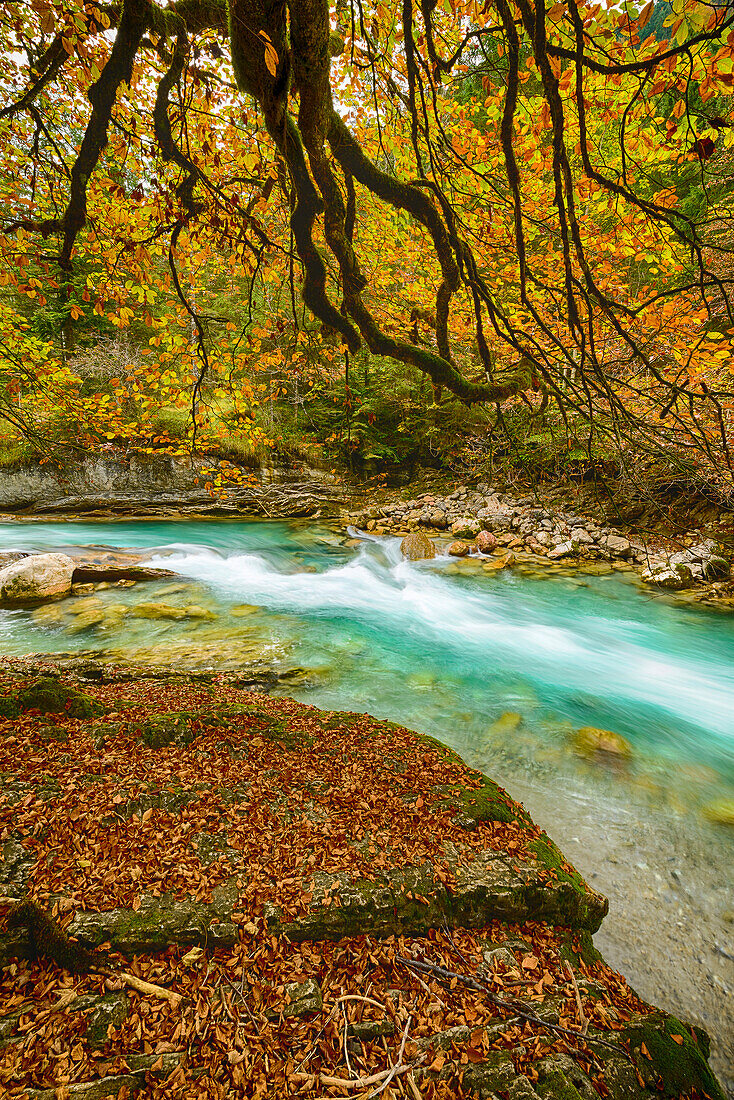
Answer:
top-left (0, 672), bottom-right (723, 1100)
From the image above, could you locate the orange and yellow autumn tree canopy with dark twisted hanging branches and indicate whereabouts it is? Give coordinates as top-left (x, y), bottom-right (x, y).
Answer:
top-left (0, 0), bottom-right (734, 485)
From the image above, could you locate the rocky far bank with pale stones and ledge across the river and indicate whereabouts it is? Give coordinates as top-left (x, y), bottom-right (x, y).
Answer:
top-left (0, 449), bottom-right (734, 609)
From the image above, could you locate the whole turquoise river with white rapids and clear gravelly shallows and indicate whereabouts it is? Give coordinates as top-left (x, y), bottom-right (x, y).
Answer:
top-left (0, 520), bottom-right (734, 1086)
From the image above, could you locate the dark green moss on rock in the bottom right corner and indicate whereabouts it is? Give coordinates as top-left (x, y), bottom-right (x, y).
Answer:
top-left (622, 1013), bottom-right (724, 1100)
